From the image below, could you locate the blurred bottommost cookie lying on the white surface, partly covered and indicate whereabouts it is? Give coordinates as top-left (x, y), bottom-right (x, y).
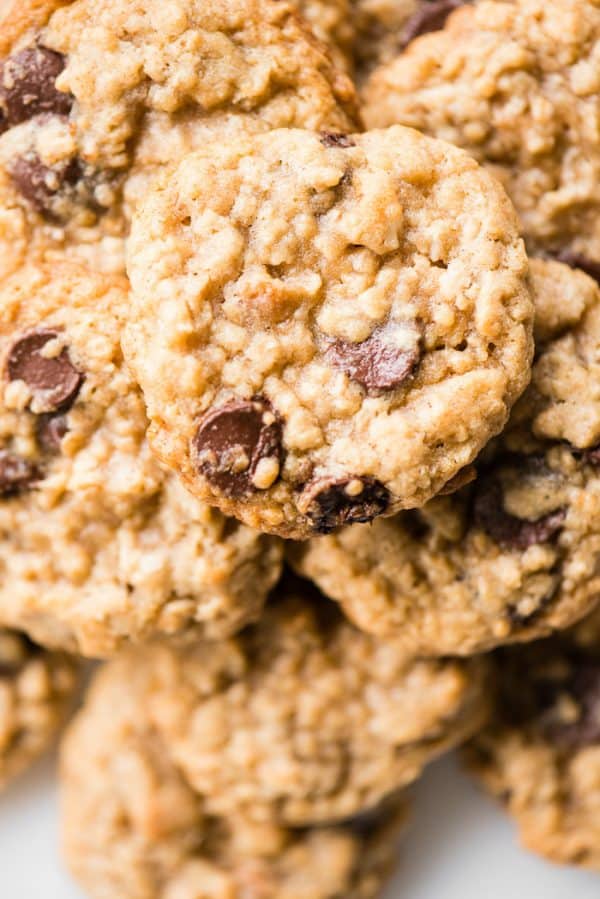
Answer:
top-left (61, 656), bottom-right (404, 899)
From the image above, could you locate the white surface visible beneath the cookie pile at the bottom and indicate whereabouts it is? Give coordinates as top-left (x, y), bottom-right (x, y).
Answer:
top-left (0, 760), bottom-right (600, 899)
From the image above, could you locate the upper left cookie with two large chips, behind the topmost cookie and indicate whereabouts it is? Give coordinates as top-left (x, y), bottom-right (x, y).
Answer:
top-left (0, 0), bottom-right (356, 274)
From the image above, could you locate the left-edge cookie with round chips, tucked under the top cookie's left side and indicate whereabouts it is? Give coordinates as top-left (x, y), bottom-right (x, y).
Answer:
top-left (0, 260), bottom-right (282, 655)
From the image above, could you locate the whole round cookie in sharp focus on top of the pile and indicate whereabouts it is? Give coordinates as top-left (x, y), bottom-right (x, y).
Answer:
top-left (126, 128), bottom-right (532, 538)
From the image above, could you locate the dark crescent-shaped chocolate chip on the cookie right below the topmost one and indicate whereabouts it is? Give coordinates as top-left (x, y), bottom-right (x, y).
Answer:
top-left (473, 477), bottom-right (567, 550)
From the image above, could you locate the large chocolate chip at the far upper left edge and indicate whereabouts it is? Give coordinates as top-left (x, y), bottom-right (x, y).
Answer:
top-left (0, 46), bottom-right (73, 132)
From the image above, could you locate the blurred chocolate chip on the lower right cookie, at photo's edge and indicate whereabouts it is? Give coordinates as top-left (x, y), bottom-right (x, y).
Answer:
top-left (538, 660), bottom-right (600, 751)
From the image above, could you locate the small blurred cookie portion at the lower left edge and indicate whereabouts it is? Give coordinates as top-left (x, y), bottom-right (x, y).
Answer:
top-left (0, 628), bottom-right (77, 789)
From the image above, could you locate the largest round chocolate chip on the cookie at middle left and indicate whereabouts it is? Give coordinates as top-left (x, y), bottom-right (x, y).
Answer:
top-left (7, 328), bottom-right (83, 412)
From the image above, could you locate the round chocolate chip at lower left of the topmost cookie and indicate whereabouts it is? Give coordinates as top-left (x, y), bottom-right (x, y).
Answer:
top-left (194, 397), bottom-right (283, 497)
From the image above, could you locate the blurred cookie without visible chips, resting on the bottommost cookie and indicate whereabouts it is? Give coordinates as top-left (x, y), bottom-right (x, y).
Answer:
top-left (94, 581), bottom-right (485, 826)
